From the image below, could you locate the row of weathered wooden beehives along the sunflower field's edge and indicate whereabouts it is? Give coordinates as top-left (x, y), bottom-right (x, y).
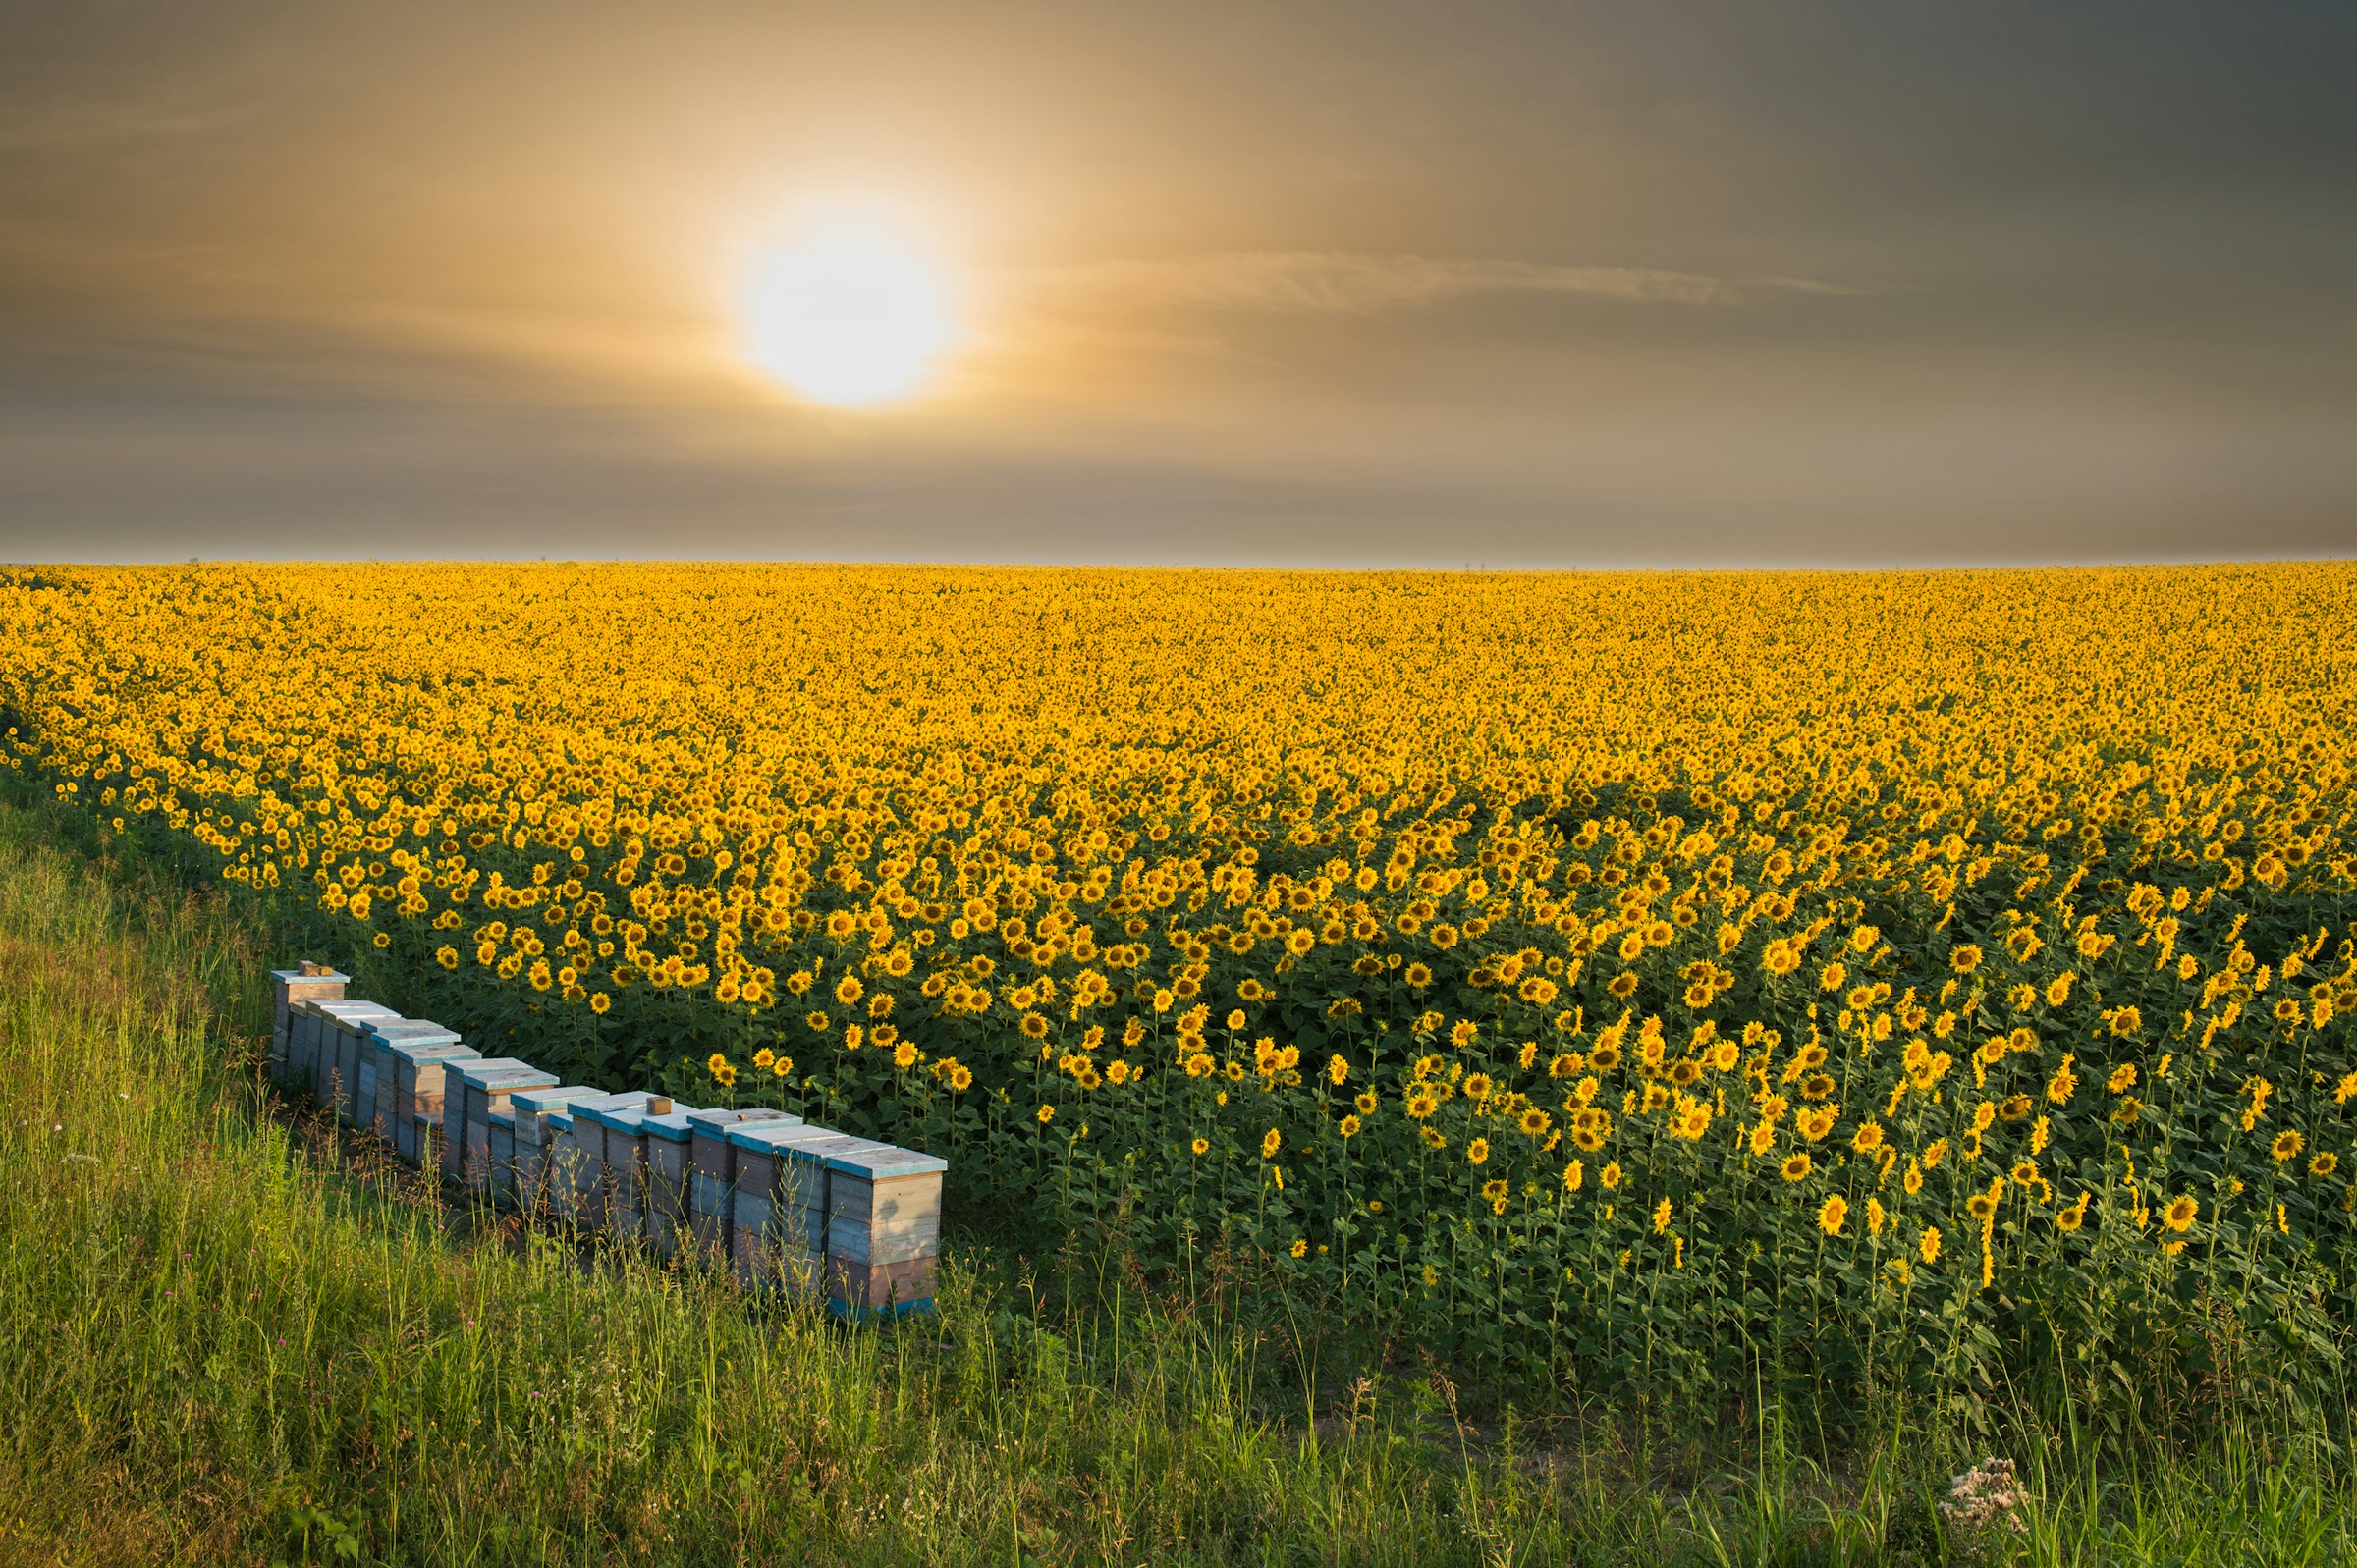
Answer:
top-left (271, 964), bottom-right (948, 1318)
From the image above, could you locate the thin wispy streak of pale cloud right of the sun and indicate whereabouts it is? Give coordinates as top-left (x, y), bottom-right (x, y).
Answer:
top-left (1025, 250), bottom-right (1763, 313)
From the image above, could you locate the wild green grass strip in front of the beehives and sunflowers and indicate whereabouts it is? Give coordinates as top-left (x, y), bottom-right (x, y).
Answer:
top-left (0, 806), bottom-right (2357, 1566)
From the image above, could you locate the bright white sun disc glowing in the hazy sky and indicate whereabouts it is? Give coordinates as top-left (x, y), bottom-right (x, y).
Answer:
top-left (742, 203), bottom-right (959, 407)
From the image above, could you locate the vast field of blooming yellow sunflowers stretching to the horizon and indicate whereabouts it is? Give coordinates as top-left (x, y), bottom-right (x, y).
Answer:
top-left (0, 564), bottom-right (2357, 1393)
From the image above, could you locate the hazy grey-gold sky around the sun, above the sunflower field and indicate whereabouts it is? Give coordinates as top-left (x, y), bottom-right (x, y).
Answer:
top-left (0, 0), bottom-right (2357, 568)
